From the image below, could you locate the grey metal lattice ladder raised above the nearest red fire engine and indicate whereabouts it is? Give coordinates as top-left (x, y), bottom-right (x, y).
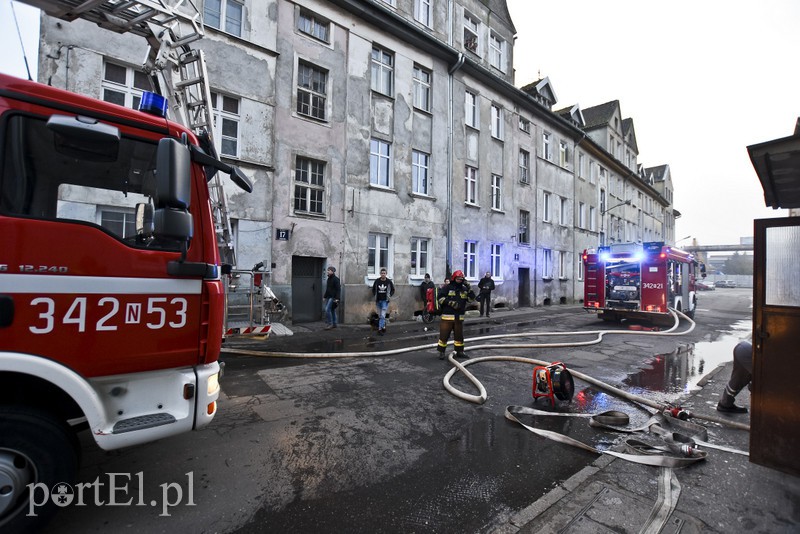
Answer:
top-left (22, 0), bottom-right (236, 266)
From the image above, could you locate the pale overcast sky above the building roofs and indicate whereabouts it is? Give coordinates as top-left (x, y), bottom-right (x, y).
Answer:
top-left (0, 0), bottom-right (800, 245)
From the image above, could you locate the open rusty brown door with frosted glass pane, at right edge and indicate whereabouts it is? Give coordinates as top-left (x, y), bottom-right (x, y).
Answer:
top-left (750, 217), bottom-right (800, 475)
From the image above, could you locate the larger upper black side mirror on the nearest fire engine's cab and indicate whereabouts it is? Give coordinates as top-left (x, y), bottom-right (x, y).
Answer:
top-left (156, 137), bottom-right (192, 210)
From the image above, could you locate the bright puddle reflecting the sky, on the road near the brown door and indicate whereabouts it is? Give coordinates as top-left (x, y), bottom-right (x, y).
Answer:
top-left (624, 320), bottom-right (752, 402)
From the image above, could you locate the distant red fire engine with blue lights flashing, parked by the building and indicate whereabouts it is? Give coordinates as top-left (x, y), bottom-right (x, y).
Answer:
top-left (583, 241), bottom-right (705, 323)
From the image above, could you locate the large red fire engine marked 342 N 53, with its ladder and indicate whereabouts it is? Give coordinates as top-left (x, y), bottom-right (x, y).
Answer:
top-left (0, 0), bottom-right (252, 532)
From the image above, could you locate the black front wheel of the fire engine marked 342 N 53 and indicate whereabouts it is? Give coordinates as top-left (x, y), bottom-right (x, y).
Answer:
top-left (0, 406), bottom-right (78, 534)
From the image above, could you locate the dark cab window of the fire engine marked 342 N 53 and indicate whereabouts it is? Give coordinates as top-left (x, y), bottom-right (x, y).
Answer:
top-left (0, 114), bottom-right (180, 250)
